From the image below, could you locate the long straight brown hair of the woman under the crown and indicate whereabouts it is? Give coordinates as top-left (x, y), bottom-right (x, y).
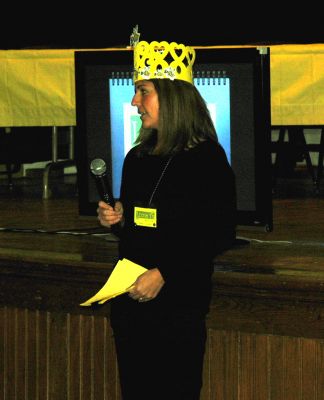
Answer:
top-left (136, 79), bottom-right (218, 156)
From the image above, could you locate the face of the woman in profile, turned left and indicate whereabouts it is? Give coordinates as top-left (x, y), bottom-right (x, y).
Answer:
top-left (132, 80), bottom-right (159, 129)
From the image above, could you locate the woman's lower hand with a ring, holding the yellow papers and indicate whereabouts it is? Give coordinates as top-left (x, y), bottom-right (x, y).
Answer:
top-left (129, 268), bottom-right (165, 302)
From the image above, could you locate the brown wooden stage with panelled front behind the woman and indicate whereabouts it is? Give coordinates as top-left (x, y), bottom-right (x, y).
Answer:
top-left (0, 199), bottom-right (324, 400)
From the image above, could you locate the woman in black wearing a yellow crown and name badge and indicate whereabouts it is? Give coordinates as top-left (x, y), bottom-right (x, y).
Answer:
top-left (98, 37), bottom-right (236, 400)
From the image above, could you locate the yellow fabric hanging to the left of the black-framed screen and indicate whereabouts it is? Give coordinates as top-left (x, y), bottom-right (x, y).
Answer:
top-left (0, 50), bottom-right (76, 127)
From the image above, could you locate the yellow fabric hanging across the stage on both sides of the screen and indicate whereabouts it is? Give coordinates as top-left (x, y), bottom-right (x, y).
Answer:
top-left (0, 44), bottom-right (324, 127)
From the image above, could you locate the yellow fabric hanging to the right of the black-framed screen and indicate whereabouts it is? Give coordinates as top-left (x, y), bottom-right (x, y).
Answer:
top-left (270, 44), bottom-right (324, 125)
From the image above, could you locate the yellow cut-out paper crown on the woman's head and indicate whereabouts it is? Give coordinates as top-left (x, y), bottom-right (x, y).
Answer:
top-left (133, 41), bottom-right (196, 83)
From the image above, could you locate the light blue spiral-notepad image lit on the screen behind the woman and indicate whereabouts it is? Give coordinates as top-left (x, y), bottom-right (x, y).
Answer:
top-left (109, 78), bottom-right (231, 198)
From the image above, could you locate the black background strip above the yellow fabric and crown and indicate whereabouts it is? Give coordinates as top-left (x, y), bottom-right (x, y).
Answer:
top-left (0, 7), bottom-right (324, 49)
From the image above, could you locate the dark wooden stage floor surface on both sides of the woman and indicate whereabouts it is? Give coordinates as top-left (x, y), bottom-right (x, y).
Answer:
top-left (0, 169), bottom-right (324, 273)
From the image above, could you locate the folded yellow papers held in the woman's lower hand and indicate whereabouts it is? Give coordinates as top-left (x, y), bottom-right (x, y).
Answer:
top-left (80, 258), bottom-right (147, 306)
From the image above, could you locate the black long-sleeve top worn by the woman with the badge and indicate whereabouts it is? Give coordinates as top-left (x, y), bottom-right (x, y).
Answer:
top-left (119, 140), bottom-right (236, 305)
